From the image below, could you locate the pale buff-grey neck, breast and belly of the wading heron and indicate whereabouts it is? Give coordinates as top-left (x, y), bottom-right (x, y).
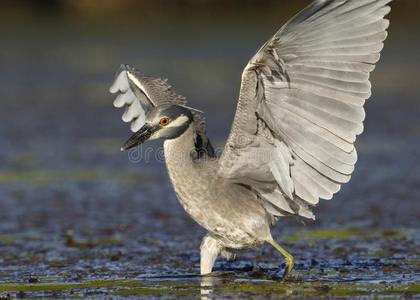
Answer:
top-left (165, 137), bottom-right (269, 248)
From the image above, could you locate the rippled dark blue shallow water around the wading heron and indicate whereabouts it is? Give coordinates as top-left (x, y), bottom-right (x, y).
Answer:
top-left (0, 1), bottom-right (420, 298)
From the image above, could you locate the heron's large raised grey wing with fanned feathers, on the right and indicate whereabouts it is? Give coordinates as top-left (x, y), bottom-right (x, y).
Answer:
top-left (219, 0), bottom-right (391, 218)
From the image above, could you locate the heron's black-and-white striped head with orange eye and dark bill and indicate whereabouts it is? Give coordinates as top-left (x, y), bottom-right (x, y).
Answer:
top-left (121, 105), bottom-right (194, 151)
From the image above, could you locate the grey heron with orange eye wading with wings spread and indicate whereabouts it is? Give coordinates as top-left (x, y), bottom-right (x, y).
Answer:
top-left (110, 0), bottom-right (392, 277)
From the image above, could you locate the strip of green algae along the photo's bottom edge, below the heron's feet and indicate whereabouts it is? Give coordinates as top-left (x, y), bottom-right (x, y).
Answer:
top-left (0, 280), bottom-right (420, 297)
